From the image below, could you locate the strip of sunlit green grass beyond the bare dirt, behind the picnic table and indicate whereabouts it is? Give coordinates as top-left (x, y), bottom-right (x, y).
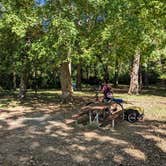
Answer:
top-left (0, 90), bottom-right (166, 120)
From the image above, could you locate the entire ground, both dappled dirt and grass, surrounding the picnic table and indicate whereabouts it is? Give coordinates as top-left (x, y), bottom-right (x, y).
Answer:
top-left (0, 88), bottom-right (166, 166)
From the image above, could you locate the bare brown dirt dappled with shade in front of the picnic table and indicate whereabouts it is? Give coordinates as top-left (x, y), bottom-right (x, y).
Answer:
top-left (0, 101), bottom-right (166, 166)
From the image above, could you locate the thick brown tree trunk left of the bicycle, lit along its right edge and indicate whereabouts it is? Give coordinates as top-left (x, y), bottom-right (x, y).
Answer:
top-left (60, 62), bottom-right (73, 102)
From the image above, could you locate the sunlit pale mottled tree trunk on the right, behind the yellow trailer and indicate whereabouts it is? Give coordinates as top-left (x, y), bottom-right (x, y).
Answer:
top-left (128, 51), bottom-right (140, 94)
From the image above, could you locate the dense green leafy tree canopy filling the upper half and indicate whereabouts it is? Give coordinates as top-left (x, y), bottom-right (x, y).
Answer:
top-left (0, 0), bottom-right (166, 97)
